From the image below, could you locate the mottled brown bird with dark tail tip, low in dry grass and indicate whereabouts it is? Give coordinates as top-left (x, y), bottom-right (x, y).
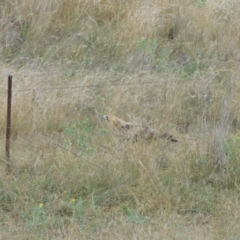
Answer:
top-left (103, 115), bottom-right (178, 142)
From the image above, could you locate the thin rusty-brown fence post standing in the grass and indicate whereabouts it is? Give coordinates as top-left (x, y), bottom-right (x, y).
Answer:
top-left (5, 75), bottom-right (12, 173)
